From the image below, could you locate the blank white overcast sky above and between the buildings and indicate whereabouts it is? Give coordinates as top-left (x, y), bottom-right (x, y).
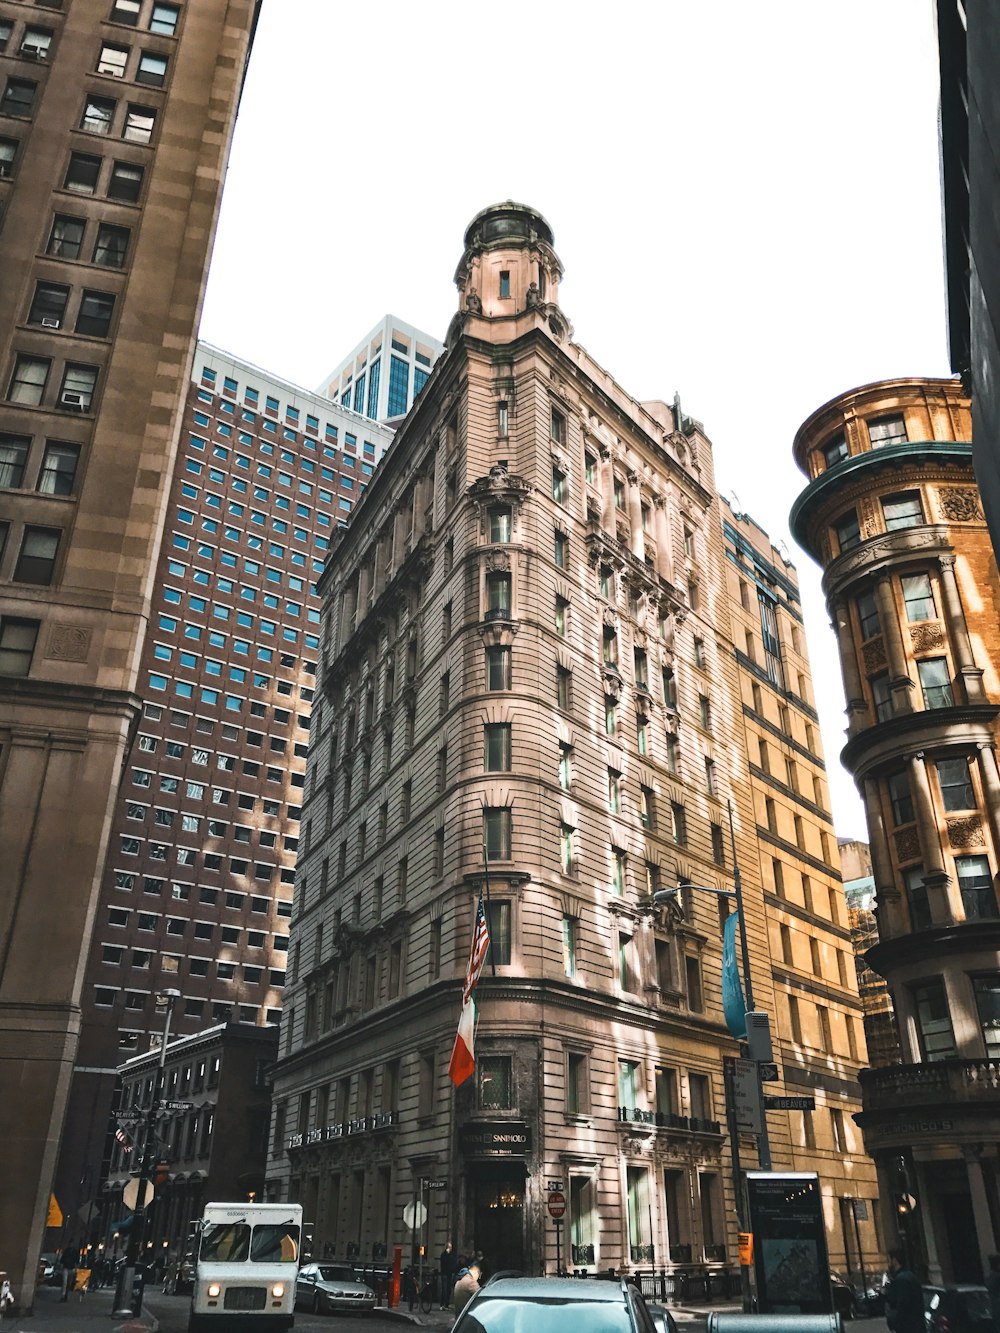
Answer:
top-left (201, 0), bottom-right (951, 837)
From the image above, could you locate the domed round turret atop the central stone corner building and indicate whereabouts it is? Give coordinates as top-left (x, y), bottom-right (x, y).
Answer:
top-left (455, 200), bottom-right (563, 319)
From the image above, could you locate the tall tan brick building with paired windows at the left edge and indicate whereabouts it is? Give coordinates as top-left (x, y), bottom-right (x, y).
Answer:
top-left (0, 0), bottom-right (257, 1305)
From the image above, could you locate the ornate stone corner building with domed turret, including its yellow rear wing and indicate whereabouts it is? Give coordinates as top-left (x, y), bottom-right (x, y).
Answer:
top-left (268, 203), bottom-right (877, 1282)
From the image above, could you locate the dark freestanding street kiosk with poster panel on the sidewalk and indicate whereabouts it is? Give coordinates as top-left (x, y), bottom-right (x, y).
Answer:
top-left (747, 1170), bottom-right (833, 1314)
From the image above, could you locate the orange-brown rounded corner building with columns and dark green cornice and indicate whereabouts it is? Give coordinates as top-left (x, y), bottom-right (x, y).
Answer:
top-left (792, 379), bottom-right (1000, 1281)
